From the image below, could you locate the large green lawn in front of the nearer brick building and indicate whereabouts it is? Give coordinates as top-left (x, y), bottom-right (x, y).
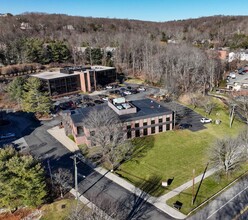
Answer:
top-left (117, 99), bottom-right (243, 196)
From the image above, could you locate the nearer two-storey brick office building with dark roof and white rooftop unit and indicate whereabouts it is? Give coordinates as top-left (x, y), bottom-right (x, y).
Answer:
top-left (64, 98), bottom-right (173, 147)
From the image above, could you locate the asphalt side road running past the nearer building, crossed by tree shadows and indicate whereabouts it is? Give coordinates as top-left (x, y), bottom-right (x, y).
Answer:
top-left (25, 119), bottom-right (173, 220)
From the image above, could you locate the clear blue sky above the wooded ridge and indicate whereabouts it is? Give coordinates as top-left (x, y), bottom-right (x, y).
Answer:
top-left (0, 0), bottom-right (248, 22)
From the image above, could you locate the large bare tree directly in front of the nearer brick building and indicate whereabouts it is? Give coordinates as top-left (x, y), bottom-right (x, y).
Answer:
top-left (85, 107), bottom-right (132, 169)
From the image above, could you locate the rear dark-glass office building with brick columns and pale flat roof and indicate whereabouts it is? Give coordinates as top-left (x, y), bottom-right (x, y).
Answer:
top-left (32, 66), bottom-right (117, 96)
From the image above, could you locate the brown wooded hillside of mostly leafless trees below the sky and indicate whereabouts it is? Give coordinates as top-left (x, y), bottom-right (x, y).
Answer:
top-left (0, 13), bottom-right (248, 92)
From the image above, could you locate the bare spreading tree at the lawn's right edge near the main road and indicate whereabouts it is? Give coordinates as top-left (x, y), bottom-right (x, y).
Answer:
top-left (210, 138), bottom-right (247, 175)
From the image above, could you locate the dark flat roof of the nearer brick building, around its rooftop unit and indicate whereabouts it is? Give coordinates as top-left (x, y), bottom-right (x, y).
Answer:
top-left (71, 98), bottom-right (172, 126)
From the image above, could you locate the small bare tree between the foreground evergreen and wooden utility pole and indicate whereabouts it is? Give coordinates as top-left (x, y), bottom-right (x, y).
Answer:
top-left (53, 168), bottom-right (72, 198)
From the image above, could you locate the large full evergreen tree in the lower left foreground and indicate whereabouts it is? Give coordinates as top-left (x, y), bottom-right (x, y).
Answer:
top-left (0, 146), bottom-right (46, 210)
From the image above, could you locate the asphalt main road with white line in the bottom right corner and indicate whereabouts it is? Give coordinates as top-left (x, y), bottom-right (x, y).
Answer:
top-left (188, 176), bottom-right (248, 220)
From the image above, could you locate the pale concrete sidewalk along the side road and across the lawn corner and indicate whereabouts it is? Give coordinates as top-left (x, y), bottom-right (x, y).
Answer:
top-left (48, 127), bottom-right (216, 219)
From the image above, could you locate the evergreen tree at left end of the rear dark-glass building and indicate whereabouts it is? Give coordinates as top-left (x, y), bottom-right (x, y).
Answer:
top-left (22, 77), bottom-right (51, 114)
